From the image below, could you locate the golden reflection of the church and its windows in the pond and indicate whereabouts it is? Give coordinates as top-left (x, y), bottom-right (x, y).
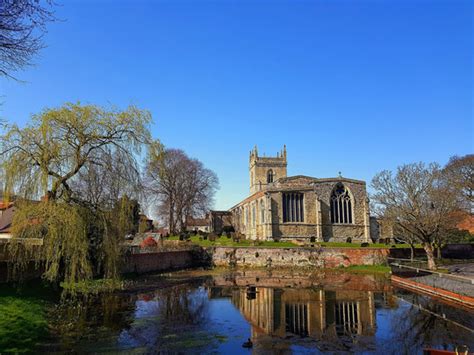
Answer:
top-left (232, 287), bottom-right (375, 340)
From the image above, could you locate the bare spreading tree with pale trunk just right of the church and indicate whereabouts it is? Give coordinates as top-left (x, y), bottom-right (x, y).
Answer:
top-left (372, 163), bottom-right (458, 269)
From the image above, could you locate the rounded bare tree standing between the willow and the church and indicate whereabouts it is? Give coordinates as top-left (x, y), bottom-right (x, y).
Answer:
top-left (145, 149), bottom-right (219, 233)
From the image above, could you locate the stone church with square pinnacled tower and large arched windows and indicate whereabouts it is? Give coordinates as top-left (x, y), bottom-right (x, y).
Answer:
top-left (230, 146), bottom-right (371, 243)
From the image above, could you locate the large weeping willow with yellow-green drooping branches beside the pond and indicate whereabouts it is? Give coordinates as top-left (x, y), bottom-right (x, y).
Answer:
top-left (0, 103), bottom-right (153, 282)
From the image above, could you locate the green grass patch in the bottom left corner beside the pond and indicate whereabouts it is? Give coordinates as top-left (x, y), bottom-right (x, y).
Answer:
top-left (0, 296), bottom-right (47, 353)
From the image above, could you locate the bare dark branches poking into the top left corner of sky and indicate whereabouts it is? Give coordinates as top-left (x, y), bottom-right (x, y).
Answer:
top-left (0, 0), bottom-right (54, 78)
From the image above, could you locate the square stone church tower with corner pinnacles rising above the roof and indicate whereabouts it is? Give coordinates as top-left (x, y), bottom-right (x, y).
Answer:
top-left (249, 145), bottom-right (287, 195)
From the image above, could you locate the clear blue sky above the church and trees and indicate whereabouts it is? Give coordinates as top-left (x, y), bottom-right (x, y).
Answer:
top-left (0, 0), bottom-right (474, 209)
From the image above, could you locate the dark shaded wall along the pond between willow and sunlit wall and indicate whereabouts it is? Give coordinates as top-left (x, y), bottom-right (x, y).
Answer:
top-left (122, 250), bottom-right (199, 274)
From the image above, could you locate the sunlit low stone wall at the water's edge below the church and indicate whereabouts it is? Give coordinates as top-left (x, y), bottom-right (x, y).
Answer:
top-left (208, 247), bottom-right (390, 268)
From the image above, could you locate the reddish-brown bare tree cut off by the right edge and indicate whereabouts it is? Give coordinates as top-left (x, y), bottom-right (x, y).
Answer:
top-left (443, 154), bottom-right (474, 213)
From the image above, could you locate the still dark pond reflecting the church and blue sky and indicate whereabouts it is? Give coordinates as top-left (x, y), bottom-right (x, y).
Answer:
top-left (0, 270), bottom-right (474, 354)
